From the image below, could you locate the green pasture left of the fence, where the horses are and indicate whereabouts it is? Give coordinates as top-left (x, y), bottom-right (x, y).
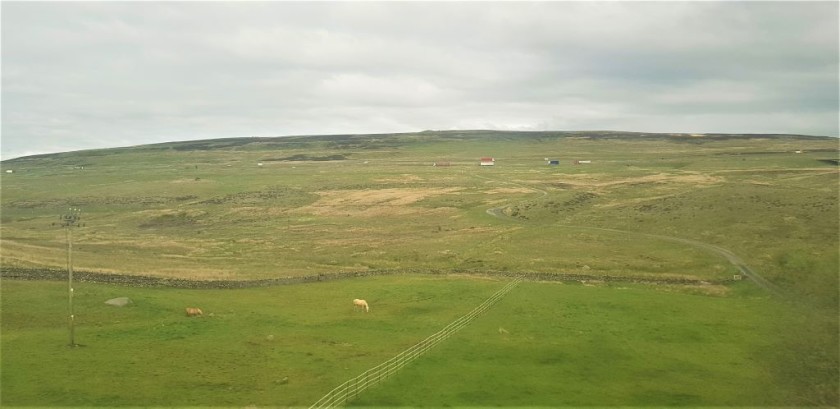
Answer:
top-left (0, 276), bottom-right (504, 407)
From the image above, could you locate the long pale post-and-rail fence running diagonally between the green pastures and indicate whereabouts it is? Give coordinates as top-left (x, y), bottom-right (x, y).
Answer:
top-left (310, 277), bottom-right (522, 409)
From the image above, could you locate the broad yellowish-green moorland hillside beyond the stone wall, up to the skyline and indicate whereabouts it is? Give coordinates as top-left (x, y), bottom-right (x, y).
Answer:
top-left (0, 132), bottom-right (838, 290)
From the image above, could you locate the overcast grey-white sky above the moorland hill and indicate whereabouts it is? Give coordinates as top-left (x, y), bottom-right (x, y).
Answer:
top-left (0, 1), bottom-right (840, 159)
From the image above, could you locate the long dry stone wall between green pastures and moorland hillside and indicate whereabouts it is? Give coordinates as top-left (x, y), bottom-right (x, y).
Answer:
top-left (0, 267), bottom-right (733, 290)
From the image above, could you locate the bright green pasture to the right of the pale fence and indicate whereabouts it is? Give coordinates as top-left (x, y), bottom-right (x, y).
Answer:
top-left (353, 283), bottom-right (811, 407)
